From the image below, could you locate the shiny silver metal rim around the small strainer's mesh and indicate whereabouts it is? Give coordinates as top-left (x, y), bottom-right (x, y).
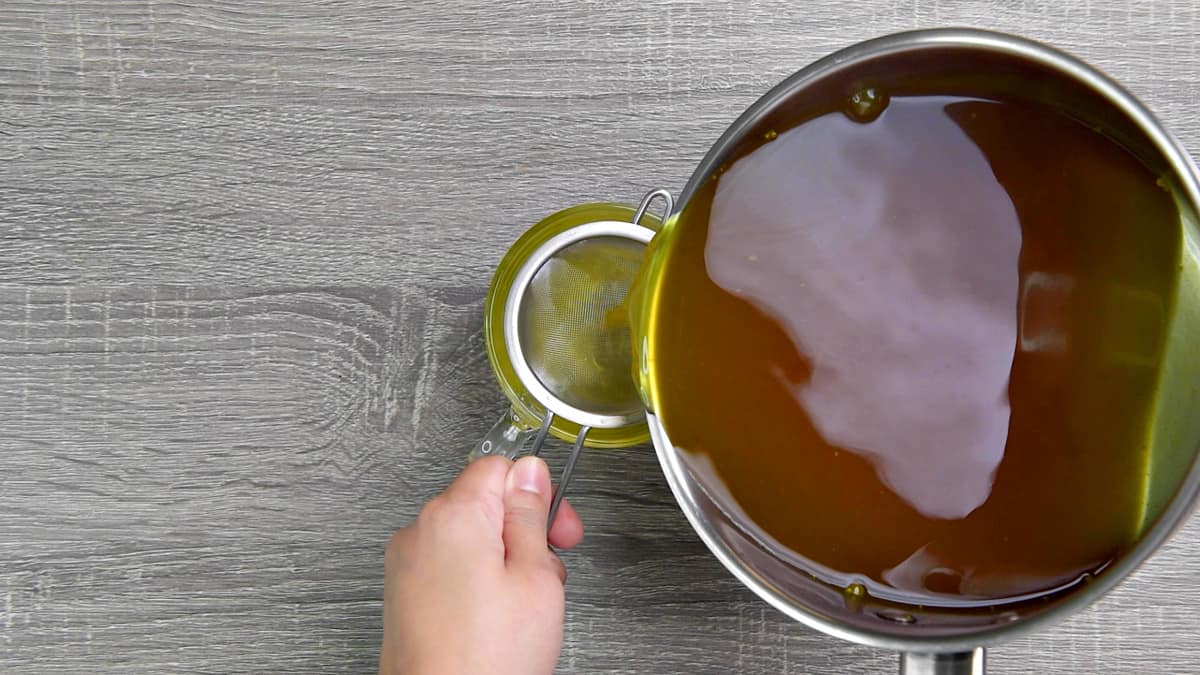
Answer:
top-left (504, 220), bottom-right (654, 429)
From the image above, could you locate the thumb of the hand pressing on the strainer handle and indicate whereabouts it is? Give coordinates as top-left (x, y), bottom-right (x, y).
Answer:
top-left (504, 456), bottom-right (550, 567)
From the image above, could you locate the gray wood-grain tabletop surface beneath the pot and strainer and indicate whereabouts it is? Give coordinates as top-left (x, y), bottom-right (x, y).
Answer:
top-left (0, 0), bottom-right (1200, 673)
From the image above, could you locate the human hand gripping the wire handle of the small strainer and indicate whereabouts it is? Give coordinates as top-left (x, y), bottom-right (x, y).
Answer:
top-left (379, 456), bottom-right (583, 675)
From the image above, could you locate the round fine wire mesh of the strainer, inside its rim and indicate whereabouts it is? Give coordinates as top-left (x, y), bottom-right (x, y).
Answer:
top-left (517, 237), bottom-right (646, 414)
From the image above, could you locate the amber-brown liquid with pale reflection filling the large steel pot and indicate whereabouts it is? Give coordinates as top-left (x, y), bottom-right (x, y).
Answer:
top-left (650, 69), bottom-right (1181, 605)
